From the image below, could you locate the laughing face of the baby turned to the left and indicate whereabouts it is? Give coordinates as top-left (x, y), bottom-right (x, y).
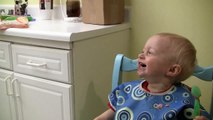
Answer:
top-left (137, 36), bottom-right (172, 79)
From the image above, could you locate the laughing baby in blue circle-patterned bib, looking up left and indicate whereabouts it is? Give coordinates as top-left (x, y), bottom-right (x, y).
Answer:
top-left (95, 33), bottom-right (211, 120)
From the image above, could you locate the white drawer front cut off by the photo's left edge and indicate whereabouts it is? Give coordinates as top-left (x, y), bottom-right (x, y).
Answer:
top-left (0, 41), bottom-right (12, 70)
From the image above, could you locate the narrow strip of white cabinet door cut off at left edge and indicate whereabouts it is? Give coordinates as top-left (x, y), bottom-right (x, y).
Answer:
top-left (0, 69), bottom-right (16, 120)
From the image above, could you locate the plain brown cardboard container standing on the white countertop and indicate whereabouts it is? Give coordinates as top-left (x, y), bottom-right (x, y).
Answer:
top-left (82, 0), bottom-right (124, 25)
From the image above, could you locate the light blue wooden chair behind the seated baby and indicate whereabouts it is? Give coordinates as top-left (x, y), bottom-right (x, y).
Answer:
top-left (112, 54), bottom-right (213, 116)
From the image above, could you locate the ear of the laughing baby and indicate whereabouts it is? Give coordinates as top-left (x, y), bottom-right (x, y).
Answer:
top-left (166, 64), bottom-right (182, 77)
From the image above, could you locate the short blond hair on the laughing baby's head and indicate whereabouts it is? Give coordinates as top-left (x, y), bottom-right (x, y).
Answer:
top-left (156, 33), bottom-right (197, 83)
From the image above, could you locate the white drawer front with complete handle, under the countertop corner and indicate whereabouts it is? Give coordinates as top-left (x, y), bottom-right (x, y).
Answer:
top-left (12, 44), bottom-right (72, 83)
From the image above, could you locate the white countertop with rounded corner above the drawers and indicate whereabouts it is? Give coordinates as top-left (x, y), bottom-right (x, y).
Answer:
top-left (0, 20), bottom-right (130, 42)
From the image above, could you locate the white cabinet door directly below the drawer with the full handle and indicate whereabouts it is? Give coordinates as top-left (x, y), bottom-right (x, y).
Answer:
top-left (13, 73), bottom-right (73, 120)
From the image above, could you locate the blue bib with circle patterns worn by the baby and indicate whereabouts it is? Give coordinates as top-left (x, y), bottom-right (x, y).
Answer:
top-left (108, 80), bottom-right (211, 120)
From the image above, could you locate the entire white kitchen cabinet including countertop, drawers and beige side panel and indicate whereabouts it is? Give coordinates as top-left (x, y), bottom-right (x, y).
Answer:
top-left (0, 20), bottom-right (129, 120)
